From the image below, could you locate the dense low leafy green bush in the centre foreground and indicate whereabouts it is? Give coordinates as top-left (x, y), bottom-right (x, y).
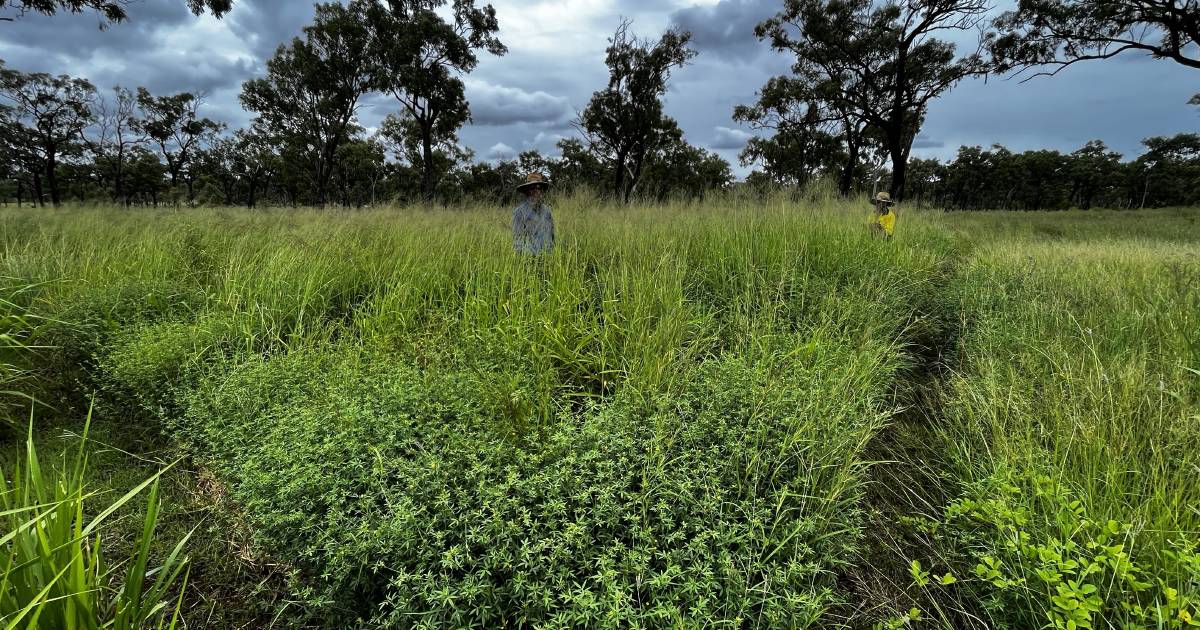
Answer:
top-left (180, 331), bottom-right (882, 628)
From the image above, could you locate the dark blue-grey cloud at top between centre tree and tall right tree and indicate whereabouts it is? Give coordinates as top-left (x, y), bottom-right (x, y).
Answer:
top-left (671, 0), bottom-right (780, 62)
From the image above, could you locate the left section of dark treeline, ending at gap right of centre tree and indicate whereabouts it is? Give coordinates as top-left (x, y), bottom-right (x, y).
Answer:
top-left (0, 0), bottom-right (733, 206)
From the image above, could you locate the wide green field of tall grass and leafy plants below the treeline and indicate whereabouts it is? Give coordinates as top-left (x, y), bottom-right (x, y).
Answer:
top-left (0, 198), bottom-right (1200, 629)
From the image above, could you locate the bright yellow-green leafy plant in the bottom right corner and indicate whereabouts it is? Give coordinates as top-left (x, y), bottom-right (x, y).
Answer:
top-left (913, 470), bottom-right (1200, 630)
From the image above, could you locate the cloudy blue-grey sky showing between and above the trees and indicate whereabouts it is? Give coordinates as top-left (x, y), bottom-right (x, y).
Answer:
top-left (0, 0), bottom-right (1200, 173)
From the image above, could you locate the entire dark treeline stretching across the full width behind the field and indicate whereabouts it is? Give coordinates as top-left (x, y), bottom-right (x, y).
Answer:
top-left (0, 0), bottom-right (1200, 210)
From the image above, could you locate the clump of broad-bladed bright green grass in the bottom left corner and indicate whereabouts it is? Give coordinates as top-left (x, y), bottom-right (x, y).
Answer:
top-left (0, 418), bottom-right (187, 630)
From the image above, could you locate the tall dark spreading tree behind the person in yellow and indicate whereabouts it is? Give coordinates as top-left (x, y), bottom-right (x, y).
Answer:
top-left (755, 0), bottom-right (990, 198)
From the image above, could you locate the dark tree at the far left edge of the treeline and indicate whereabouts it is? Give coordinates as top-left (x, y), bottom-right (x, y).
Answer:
top-left (0, 66), bottom-right (96, 205)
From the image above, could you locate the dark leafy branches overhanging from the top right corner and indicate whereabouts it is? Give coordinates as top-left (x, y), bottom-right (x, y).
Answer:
top-left (990, 0), bottom-right (1200, 76)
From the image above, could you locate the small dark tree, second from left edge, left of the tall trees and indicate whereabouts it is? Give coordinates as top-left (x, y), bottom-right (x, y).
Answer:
top-left (136, 88), bottom-right (224, 204)
